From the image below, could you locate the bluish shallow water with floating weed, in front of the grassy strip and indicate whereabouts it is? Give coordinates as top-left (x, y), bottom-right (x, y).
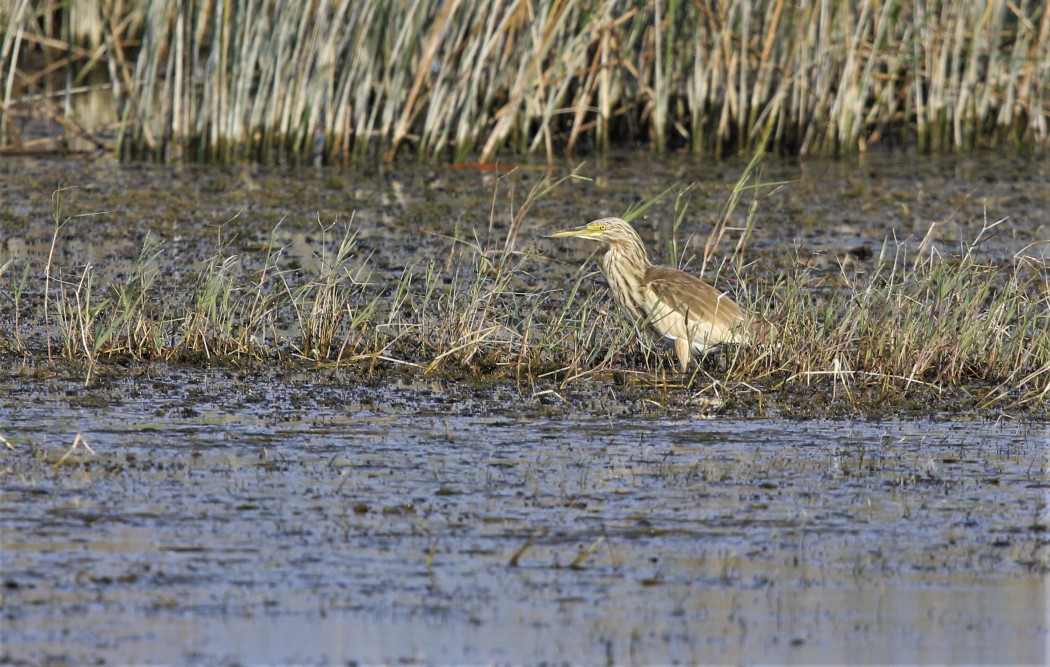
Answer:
top-left (0, 369), bottom-right (1050, 663)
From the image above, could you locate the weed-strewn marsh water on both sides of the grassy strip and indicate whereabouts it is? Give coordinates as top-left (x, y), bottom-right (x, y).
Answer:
top-left (0, 153), bottom-right (1050, 664)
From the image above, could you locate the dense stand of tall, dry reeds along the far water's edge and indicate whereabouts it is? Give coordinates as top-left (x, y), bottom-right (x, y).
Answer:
top-left (0, 0), bottom-right (1050, 163)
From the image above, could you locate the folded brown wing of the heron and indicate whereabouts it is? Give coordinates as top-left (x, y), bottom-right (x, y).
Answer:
top-left (645, 267), bottom-right (748, 336)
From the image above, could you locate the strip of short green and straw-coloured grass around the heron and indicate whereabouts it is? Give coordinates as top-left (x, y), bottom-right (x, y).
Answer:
top-left (0, 177), bottom-right (1050, 411)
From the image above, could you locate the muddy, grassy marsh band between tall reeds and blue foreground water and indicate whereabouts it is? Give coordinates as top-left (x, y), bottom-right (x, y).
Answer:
top-left (0, 153), bottom-right (1050, 416)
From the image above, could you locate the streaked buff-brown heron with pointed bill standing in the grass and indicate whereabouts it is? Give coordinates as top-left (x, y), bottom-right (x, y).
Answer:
top-left (547, 217), bottom-right (750, 372)
